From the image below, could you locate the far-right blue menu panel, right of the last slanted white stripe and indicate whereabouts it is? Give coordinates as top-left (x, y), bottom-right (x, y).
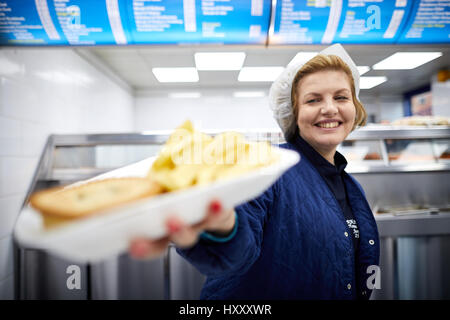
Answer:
top-left (398, 0), bottom-right (450, 44)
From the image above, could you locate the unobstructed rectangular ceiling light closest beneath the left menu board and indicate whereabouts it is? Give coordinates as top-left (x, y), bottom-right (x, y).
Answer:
top-left (194, 52), bottom-right (245, 70)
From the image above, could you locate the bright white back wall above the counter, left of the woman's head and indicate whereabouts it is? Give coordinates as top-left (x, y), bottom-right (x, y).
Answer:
top-left (135, 89), bottom-right (279, 131)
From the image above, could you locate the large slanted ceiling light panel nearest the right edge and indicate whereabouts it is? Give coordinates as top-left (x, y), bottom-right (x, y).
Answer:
top-left (372, 52), bottom-right (442, 70)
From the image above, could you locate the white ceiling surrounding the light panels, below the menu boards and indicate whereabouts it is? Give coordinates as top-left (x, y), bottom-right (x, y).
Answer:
top-left (82, 45), bottom-right (450, 96)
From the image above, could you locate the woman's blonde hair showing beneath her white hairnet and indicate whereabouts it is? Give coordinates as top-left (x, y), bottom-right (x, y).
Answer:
top-left (291, 54), bottom-right (367, 131)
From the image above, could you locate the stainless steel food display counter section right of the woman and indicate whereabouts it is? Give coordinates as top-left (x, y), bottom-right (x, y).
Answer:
top-left (338, 125), bottom-right (450, 299)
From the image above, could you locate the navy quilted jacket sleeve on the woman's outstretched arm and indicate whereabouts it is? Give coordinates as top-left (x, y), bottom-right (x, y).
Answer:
top-left (177, 184), bottom-right (276, 276)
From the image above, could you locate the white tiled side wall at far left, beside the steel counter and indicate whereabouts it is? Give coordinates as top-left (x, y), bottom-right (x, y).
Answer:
top-left (0, 48), bottom-right (134, 299)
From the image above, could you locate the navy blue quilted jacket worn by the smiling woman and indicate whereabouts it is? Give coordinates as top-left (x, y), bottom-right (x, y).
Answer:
top-left (177, 143), bottom-right (380, 299)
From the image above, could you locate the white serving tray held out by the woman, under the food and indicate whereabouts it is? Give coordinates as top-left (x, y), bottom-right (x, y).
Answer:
top-left (14, 147), bottom-right (300, 263)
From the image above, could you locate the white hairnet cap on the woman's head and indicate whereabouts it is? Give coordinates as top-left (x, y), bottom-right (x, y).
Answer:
top-left (269, 44), bottom-right (359, 140)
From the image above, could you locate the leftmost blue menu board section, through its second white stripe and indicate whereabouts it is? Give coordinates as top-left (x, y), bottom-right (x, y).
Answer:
top-left (0, 0), bottom-right (128, 45)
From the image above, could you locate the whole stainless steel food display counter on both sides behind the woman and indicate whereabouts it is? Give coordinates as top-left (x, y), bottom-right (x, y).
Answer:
top-left (15, 126), bottom-right (450, 299)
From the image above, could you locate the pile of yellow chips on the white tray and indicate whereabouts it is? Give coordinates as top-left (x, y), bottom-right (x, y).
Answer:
top-left (149, 121), bottom-right (278, 191)
